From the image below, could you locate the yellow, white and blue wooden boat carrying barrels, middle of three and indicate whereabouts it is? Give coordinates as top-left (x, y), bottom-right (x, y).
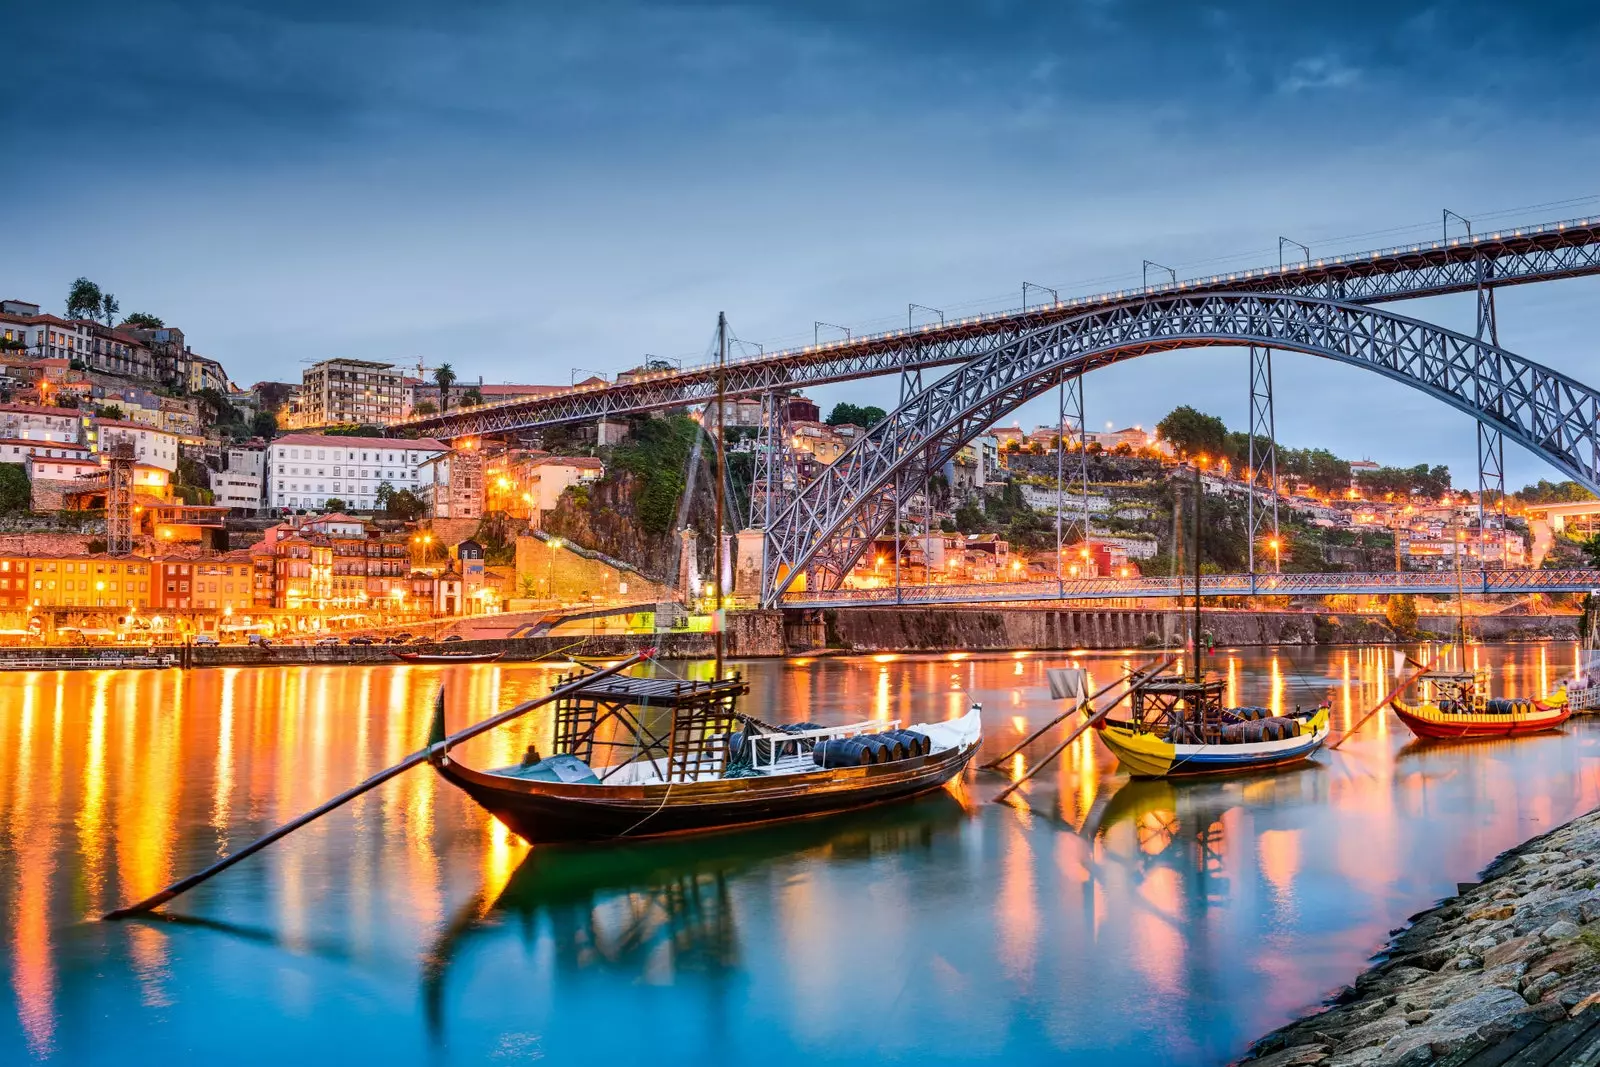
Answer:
top-left (1094, 678), bottom-right (1328, 777)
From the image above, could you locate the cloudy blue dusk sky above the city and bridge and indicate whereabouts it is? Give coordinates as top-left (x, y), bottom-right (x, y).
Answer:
top-left (9, 0), bottom-right (1600, 485)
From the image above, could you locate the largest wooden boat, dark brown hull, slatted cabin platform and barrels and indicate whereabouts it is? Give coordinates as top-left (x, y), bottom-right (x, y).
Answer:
top-left (434, 675), bottom-right (981, 843)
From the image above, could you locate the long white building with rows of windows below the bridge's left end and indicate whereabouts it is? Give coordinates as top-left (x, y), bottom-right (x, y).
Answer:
top-left (266, 434), bottom-right (450, 510)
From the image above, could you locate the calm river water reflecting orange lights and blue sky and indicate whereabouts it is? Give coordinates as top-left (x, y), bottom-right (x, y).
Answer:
top-left (0, 645), bottom-right (1600, 1065)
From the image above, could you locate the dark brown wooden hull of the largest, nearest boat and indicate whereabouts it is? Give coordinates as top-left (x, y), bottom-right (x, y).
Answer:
top-left (434, 741), bottom-right (978, 845)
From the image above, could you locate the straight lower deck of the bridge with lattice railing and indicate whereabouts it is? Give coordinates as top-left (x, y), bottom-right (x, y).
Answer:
top-left (782, 569), bottom-right (1600, 608)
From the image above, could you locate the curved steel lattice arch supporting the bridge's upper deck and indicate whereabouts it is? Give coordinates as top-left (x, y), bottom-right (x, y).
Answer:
top-left (762, 291), bottom-right (1600, 606)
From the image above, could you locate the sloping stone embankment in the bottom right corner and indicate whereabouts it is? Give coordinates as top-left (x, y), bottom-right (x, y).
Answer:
top-left (1243, 813), bottom-right (1600, 1067)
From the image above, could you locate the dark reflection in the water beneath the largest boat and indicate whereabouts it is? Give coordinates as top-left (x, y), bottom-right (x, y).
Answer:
top-left (422, 790), bottom-right (966, 1037)
